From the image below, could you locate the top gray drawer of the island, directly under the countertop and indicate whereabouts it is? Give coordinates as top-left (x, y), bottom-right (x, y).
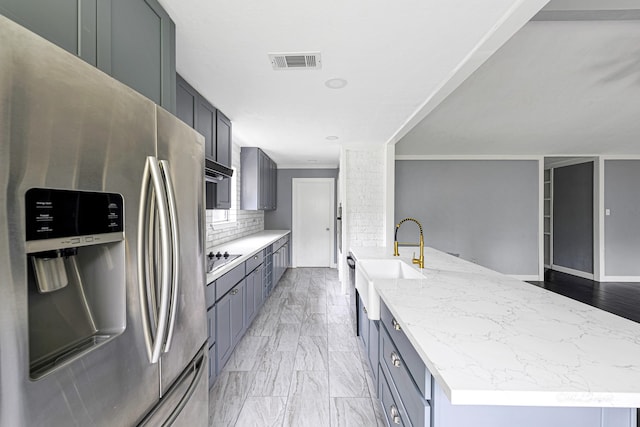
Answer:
top-left (380, 302), bottom-right (431, 399)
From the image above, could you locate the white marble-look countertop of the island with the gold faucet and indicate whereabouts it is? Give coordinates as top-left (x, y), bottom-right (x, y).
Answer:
top-left (352, 248), bottom-right (640, 408)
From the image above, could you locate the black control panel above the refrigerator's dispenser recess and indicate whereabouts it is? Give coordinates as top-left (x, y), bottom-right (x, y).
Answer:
top-left (25, 188), bottom-right (124, 241)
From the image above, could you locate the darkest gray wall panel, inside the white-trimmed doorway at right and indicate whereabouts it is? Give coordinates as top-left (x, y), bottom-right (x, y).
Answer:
top-left (552, 162), bottom-right (593, 273)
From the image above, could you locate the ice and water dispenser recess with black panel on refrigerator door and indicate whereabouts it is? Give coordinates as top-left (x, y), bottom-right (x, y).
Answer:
top-left (25, 188), bottom-right (126, 379)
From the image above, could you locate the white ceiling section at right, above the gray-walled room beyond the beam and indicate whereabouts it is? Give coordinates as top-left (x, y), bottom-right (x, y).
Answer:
top-left (396, 10), bottom-right (640, 155)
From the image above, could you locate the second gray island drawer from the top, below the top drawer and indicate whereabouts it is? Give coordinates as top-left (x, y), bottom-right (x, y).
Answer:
top-left (380, 328), bottom-right (429, 426)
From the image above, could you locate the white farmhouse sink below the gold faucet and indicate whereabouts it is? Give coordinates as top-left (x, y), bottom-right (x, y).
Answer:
top-left (356, 258), bottom-right (424, 320)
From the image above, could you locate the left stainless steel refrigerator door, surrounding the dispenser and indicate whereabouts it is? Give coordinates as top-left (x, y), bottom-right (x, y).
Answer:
top-left (0, 16), bottom-right (159, 426)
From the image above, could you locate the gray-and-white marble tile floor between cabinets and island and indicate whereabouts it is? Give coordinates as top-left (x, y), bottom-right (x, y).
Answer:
top-left (209, 268), bottom-right (386, 427)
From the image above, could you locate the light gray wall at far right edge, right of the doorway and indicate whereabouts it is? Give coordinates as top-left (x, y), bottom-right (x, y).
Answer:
top-left (604, 160), bottom-right (640, 276)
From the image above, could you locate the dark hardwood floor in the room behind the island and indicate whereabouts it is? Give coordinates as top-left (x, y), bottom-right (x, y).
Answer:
top-left (528, 270), bottom-right (640, 323)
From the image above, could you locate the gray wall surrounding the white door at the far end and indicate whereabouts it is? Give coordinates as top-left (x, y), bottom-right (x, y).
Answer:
top-left (264, 169), bottom-right (338, 262)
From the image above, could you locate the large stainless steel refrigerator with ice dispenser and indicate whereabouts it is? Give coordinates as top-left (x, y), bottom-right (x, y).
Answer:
top-left (0, 16), bottom-right (208, 427)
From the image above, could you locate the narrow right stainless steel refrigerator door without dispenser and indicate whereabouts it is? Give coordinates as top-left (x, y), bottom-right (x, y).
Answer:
top-left (157, 107), bottom-right (207, 398)
